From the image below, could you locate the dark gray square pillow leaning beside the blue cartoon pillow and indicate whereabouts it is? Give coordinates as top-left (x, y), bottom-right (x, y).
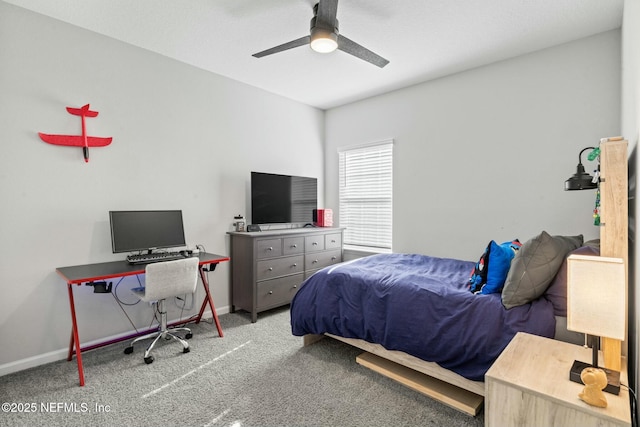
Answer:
top-left (502, 231), bottom-right (583, 308)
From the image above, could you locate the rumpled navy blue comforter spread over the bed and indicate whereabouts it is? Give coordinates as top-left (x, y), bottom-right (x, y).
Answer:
top-left (291, 254), bottom-right (555, 381)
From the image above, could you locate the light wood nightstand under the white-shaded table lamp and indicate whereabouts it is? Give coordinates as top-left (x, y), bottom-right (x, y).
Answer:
top-left (484, 332), bottom-right (631, 427)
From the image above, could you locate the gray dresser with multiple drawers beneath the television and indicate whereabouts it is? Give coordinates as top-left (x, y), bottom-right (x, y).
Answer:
top-left (228, 227), bottom-right (343, 322)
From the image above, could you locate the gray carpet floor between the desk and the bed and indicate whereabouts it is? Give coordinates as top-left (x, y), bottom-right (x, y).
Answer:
top-left (0, 307), bottom-right (484, 427)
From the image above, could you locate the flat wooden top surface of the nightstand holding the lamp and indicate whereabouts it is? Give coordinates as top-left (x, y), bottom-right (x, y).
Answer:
top-left (485, 332), bottom-right (631, 425)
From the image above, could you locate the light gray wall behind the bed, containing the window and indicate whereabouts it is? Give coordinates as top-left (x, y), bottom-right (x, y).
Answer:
top-left (325, 30), bottom-right (620, 260)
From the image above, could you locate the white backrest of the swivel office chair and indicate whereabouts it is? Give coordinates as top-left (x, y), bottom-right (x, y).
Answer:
top-left (143, 257), bottom-right (199, 301)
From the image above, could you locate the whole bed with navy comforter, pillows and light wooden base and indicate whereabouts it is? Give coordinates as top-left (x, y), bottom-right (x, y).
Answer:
top-left (291, 237), bottom-right (598, 415)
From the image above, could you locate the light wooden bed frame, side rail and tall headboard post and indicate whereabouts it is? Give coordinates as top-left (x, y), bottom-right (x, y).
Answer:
top-left (303, 138), bottom-right (628, 416)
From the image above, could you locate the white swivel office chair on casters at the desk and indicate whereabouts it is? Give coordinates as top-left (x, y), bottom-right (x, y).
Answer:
top-left (124, 257), bottom-right (198, 364)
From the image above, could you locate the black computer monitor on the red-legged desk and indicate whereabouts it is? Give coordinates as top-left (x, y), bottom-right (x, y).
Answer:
top-left (109, 210), bottom-right (186, 253)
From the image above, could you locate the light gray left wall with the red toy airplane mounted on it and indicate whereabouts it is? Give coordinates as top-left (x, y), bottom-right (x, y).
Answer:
top-left (0, 2), bottom-right (324, 374)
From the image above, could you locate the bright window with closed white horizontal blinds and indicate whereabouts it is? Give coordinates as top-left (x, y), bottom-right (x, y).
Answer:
top-left (338, 140), bottom-right (393, 251)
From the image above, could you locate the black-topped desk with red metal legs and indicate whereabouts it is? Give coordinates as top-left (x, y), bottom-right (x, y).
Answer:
top-left (56, 252), bottom-right (229, 386)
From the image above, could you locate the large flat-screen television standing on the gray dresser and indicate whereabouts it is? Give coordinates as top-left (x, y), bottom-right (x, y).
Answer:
top-left (251, 172), bottom-right (318, 224)
